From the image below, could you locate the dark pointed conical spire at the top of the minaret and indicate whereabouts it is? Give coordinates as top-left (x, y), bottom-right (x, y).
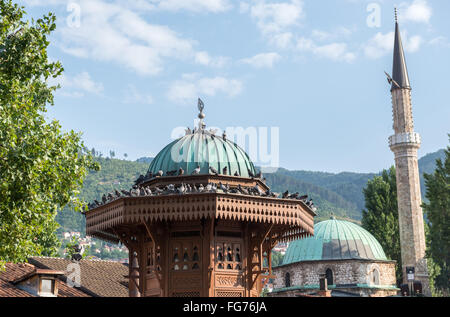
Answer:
top-left (392, 9), bottom-right (411, 89)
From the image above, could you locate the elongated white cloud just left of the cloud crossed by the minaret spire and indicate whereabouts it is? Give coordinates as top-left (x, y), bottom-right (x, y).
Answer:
top-left (297, 37), bottom-right (356, 63)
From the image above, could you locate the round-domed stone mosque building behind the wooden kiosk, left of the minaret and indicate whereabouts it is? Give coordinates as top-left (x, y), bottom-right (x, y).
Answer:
top-left (270, 217), bottom-right (399, 297)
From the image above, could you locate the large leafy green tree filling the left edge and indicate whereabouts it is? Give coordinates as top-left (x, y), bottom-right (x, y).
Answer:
top-left (0, 0), bottom-right (98, 266)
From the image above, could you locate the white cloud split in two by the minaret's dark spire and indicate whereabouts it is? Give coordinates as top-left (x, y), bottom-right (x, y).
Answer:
top-left (363, 32), bottom-right (423, 59)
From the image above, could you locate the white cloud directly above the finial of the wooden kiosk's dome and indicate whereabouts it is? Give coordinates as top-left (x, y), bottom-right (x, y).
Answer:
top-left (167, 74), bottom-right (243, 104)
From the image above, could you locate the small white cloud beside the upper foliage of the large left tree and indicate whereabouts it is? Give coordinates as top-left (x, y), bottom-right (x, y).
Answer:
top-left (50, 71), bottom-right (104, 98)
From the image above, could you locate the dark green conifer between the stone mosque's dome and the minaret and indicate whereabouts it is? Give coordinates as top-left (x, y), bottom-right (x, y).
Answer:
top-left (362, 167), bottom-right (402, 283)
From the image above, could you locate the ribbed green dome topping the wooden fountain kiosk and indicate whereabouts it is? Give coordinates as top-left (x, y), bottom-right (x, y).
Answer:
top-left (149, 130), bottom-right (256, 177)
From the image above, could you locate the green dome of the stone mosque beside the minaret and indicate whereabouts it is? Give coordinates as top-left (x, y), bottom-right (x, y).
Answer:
top-left (283, 219), bottom-right (387, 265)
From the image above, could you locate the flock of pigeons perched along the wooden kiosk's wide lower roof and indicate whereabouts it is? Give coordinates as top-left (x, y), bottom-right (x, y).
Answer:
top-left (88, 182), bottom-right (317, 211)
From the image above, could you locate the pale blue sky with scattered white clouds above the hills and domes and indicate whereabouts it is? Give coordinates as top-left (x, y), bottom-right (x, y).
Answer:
top-left (18, 0), bottom-right (450, 173)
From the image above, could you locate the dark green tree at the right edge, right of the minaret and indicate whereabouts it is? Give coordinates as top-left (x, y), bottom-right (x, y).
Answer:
top-left (422, 135), bottom-right (450, 294)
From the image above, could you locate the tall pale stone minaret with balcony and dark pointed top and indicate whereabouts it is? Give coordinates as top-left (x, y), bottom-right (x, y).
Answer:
top-left (389, 12), bottom-right (430, 295)
